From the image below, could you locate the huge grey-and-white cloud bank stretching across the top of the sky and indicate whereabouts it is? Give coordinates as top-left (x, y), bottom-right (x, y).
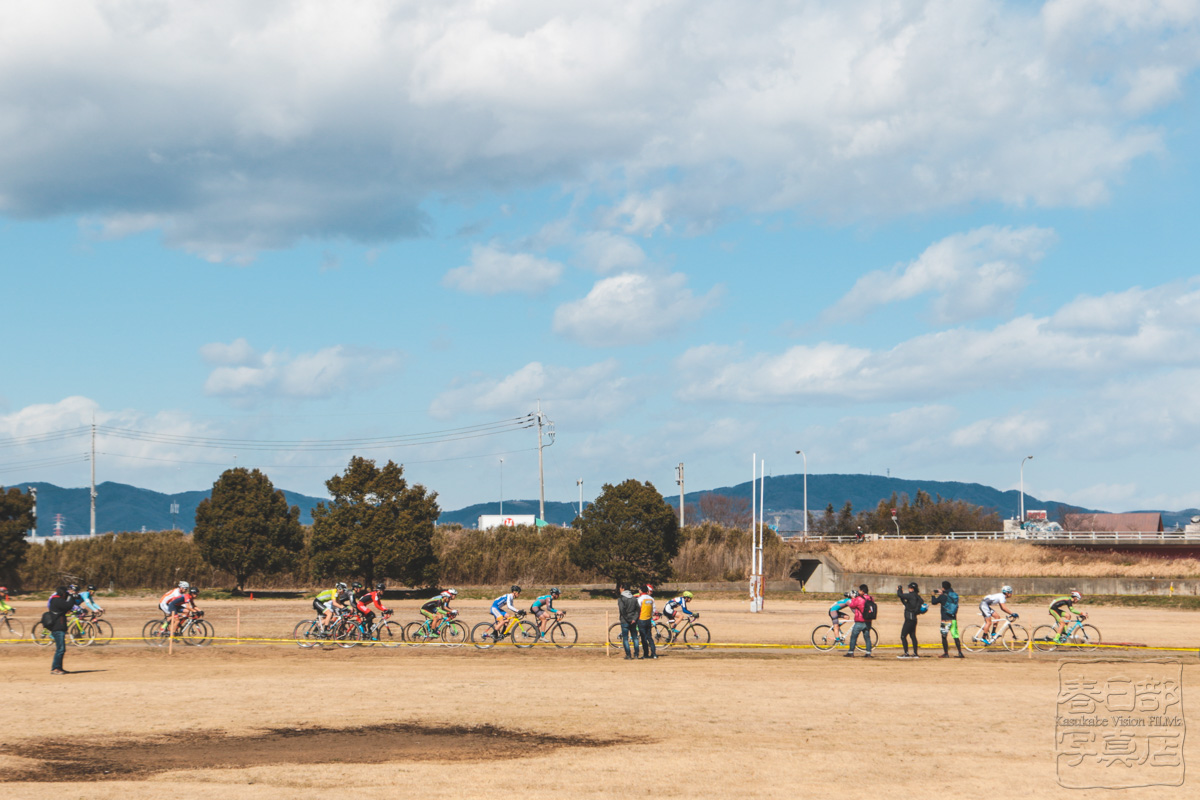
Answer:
top-left (0, 0), bottom-right (1200, 260)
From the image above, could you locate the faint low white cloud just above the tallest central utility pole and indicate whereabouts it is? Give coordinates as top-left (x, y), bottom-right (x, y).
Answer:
top-left (430, 359), bottom-right (636, 423)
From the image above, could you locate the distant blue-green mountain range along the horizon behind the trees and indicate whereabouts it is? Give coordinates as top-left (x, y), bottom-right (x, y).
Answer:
top-left (10, 475), bottom-right (1200, 536)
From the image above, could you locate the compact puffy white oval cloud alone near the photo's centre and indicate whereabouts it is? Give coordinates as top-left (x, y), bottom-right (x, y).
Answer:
top-left (554, 272), bottom-right (721, 347)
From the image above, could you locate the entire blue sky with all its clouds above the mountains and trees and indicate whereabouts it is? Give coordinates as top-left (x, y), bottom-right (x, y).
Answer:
top-left (0, 0), bottom-right (1200, 511)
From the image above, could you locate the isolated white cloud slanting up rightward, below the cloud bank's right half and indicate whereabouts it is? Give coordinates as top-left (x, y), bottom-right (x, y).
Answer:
top-left (824, 225), bottom-right (1054, 323)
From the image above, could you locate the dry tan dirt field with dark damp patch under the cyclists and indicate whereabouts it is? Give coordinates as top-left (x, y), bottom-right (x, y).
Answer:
top-left (0, 597), bottom-right (1200, 800)
